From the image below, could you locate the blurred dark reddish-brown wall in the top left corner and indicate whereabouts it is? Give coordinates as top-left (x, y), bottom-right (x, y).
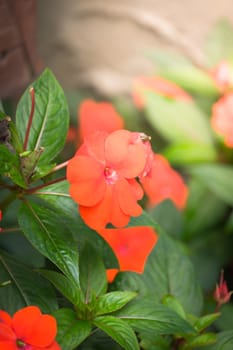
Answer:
top-left (0, 0), bottom-right (42, 99)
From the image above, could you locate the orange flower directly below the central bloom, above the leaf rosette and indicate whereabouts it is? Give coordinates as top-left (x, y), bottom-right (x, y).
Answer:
top-left (99, 226), bottom-right (158, 282)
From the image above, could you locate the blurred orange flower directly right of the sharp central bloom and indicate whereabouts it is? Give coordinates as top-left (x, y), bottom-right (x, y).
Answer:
top-left (140, 154), bottom-right (188, 209)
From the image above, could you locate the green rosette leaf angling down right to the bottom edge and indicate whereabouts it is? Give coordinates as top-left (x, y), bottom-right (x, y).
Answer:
top-left (93, 316), bottom-right (139, 350)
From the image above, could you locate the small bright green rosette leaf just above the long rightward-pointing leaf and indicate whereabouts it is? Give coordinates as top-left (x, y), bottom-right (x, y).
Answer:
top-left (95, 291), bottom-right (137, 316)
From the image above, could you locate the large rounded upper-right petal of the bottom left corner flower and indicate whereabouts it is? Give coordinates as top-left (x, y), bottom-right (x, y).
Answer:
top-left (13, 306), bottom-right (57, 347)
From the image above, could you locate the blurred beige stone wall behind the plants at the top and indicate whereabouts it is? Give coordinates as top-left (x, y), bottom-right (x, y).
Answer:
top-left (37, 0), bottom-right (233, 96)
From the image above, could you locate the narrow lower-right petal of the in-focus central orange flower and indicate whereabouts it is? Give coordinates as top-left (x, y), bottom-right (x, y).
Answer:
top-left (115, 179), bottom-right (142, 216)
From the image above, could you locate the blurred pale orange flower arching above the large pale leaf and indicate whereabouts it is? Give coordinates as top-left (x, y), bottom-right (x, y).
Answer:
top-left (133, 76), bottom-right (192, 108)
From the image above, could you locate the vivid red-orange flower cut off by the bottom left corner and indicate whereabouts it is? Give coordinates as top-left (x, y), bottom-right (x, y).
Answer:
top-left (0, 306), bottom-right (61, 350)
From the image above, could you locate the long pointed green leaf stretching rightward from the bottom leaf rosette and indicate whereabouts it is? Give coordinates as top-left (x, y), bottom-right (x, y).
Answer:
top-left (115, 297), bottom-right (195, 335)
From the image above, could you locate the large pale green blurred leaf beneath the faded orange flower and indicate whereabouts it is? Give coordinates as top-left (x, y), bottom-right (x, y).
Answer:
top-left (145, 91), bottom-right (213, 148)
